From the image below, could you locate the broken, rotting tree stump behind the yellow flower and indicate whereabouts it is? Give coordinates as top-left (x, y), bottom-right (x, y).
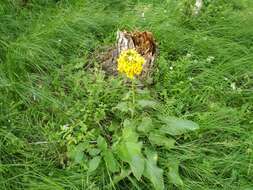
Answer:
top-left (99, 31), bottom-right (156, 81)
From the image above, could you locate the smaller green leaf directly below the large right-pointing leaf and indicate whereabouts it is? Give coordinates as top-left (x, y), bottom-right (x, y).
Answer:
top-left (148, 133), bottom-right (176, 149)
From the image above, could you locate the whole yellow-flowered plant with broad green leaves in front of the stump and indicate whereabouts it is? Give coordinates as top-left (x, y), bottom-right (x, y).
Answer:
top-left (60, 50), bottom-right (199, 190)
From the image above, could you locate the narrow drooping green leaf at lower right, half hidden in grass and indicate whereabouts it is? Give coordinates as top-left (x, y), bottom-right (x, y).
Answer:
top-left (168, 160), bottom-right (183, 186)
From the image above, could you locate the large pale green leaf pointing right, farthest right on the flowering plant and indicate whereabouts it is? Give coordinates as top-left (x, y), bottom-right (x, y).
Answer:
top-left (159, 117), bottom-right (199, 136)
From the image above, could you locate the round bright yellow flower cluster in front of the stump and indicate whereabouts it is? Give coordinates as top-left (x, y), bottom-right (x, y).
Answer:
top-left (118, 49), bottom-right (145, 79)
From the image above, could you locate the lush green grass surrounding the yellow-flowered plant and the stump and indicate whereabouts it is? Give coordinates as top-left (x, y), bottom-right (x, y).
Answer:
top-left (0, 0), bottom-right (253, 190)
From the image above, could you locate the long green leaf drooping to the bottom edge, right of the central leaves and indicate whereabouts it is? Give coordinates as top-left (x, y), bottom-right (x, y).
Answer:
top-left (144, 151), bottom-right (164, 190)
